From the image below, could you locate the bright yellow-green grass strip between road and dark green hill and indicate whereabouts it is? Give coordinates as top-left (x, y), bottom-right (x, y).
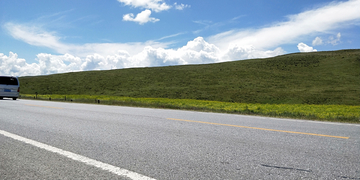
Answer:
top-left (21, 94), bottom-right (360, 123)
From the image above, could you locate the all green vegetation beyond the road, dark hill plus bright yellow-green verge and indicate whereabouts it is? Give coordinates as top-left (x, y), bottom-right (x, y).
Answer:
top-left (19, 50), bottom-right (360, 123)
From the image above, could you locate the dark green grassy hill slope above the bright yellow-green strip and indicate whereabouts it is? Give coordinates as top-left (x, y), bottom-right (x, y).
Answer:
top-left (19, 50), bottom-right (360, 105)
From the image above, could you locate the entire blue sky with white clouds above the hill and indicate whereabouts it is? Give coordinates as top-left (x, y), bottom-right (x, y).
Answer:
top-left (0, 0), bottom-right (360, 76)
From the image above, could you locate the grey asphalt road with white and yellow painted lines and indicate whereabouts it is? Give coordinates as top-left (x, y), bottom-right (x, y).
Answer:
top-left (0, 99), bottom-right (360, 180)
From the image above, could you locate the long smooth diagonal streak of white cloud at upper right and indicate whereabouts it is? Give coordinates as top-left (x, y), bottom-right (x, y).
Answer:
top-left (208, 0), bottom-right (360, 50)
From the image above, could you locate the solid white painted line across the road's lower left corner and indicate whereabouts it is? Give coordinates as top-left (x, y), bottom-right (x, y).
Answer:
top-left (0, 130), bottom-right (155, 180)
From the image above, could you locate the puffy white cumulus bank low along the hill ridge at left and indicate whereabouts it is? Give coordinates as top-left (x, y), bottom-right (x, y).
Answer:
top-left (0, 37), bottom-right (222, 76)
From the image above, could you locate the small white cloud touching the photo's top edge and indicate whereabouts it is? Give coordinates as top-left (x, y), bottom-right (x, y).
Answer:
top-left (118, 0), bottom-right (171, 12)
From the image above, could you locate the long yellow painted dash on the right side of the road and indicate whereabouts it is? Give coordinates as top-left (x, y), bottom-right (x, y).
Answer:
top-left (167, 118), bottom-right (349, 139)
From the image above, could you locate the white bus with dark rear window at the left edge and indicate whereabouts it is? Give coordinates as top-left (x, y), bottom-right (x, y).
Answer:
top-left (0, 76), bottom-right (20, 100)
